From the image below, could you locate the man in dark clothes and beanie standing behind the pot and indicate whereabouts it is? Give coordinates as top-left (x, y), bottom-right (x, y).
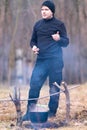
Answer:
top-left (23, 0), bottom-right (69, 121)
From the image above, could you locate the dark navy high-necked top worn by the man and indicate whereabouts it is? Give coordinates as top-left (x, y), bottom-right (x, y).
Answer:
top-left (30, 17), bottom-right (69, 65)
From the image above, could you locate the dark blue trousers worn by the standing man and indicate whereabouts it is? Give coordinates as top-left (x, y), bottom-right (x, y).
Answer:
top-left (27, 59), bottom-right (63, 113)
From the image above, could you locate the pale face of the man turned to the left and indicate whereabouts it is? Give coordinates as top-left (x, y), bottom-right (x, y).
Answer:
top-left (41, 6), bottom-right (53, 19)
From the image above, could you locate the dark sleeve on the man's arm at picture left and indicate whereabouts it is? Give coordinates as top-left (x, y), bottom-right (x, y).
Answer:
top-left (30, 26), bottom-right (37, 48)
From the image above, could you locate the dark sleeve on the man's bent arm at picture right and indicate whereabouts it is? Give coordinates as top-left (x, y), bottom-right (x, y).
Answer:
top-left (58, 23), bottom-right (69, 47)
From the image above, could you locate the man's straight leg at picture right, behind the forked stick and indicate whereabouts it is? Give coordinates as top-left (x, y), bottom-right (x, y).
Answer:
top-left (49, 61), bottom-right (62, 115)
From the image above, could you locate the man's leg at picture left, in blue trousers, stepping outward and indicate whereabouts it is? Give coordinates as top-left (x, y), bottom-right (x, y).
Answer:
top-left (23, 61), bottom-right (47, 121)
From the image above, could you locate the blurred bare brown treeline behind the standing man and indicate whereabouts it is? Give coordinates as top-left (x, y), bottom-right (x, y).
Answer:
top-left (0, 0), bottom-right (87, 83)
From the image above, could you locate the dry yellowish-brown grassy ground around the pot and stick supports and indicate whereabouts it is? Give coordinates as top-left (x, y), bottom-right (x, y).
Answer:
top-left (0, 83), bottom-right (87, 130)
